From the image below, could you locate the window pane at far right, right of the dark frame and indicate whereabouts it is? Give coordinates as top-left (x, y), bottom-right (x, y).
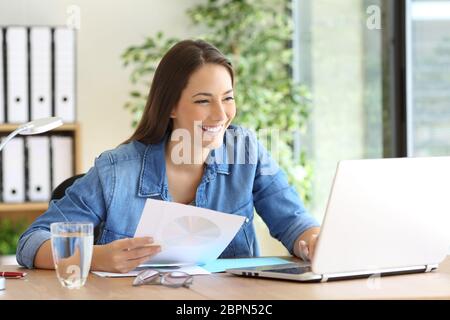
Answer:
top-left (406, 0), bottom-right (450, 156)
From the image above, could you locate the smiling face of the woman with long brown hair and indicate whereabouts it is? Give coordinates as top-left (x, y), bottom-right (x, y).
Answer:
top-left (171, 63), bottom-right (236, 149)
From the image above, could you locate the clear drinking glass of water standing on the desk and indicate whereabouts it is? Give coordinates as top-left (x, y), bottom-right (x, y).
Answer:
top-left (50, 222), bottom-right (94, 289)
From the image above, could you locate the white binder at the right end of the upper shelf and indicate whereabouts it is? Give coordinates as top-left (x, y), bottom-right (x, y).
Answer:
top-left (54, 28), bottom-right (75, 122)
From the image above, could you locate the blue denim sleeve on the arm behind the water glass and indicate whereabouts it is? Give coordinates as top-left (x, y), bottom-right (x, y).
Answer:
top-left (16, 159), bottom-right (113, 269)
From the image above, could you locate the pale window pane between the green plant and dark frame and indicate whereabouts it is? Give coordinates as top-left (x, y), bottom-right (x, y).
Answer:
top-left (293, 0), bottom-right (384, 221)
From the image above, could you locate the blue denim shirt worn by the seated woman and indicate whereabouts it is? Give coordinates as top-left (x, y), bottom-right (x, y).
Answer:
top-left (16, 126), bottom-right (319, 268)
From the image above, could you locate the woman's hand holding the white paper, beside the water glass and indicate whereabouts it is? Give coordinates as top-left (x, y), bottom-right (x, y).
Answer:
top-left (92, 237), bottom-right (161, 273)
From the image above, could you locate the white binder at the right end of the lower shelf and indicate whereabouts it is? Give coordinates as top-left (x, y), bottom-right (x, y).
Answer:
top-left (50, 136), bottom-right (74, 189)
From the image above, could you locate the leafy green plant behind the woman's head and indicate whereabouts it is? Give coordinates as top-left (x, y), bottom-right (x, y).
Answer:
top-left (122, 0), bottom-right (312, 203)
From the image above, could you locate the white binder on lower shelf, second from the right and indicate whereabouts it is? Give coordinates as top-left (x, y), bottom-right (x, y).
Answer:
top-left (26, 136), bottom-right (51, 201)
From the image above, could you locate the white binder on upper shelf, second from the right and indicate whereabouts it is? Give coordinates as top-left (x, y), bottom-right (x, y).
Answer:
top-left (30, 27), bottom-right (52, 120)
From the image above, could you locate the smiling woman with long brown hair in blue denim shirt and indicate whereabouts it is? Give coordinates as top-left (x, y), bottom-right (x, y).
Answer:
top-left (17, 40), bottom-right (319, 272)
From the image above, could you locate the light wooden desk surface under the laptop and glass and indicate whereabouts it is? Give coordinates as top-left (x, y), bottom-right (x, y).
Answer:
top-left (0, 257), bottom-right (450, 300)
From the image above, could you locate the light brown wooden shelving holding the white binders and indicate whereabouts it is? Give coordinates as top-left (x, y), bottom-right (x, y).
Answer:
top-left (0, 123), bottom-right (81, 223)
